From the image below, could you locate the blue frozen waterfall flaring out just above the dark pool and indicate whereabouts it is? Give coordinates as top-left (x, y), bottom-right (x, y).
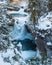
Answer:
top-left (11, 20), bottom-right (33, 40)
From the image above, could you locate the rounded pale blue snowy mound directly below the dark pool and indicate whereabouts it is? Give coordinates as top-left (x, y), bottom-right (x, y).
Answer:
top-left (21, 50), bottom-right (37, 60)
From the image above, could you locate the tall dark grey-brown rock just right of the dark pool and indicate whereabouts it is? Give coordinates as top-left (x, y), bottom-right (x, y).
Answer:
top-left (36, 36), bottom-right (47, 56)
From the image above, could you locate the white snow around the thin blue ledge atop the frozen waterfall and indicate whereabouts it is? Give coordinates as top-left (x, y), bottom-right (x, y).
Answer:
top-left (7, 8), bottom-right (30, 25)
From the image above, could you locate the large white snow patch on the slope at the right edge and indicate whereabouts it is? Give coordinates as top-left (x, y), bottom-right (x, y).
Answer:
top-left (36, 12), bottom-right (52, 30)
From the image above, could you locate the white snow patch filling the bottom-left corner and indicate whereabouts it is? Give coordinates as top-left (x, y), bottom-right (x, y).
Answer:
top-left (0, 49), bottom-right (19, 65)
